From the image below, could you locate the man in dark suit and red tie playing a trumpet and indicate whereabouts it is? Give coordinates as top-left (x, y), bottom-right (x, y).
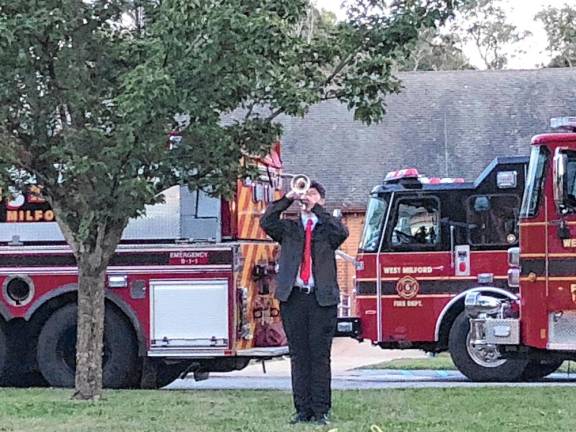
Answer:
top-left (260, 176), bottom-right (348, 424)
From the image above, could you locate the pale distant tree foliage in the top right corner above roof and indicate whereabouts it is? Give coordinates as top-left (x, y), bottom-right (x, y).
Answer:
top-left (535, 3), bottom-right (576, 67)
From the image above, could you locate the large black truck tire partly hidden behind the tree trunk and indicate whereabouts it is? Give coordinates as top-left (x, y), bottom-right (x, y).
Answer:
top-left (37, 303), bottom-right (139, 388)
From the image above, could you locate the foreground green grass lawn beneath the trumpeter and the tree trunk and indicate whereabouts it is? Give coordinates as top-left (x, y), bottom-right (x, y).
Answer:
top-left (0, 387), bottom-right (576, 432)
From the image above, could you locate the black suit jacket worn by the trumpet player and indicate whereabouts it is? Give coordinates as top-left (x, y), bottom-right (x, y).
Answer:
top-left (260, 197), bottom-right (348, 306)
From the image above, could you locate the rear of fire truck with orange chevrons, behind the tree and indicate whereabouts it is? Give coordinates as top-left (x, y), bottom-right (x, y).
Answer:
top-left (0, 144), bottom-right (288, 388)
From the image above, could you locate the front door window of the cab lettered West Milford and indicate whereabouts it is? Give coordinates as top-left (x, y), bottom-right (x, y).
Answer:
top-left (391, 198), bottom-right (440, 249)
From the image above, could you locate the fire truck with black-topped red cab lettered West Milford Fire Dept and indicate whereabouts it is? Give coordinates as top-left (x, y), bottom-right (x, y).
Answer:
top-left (346, 156), bottom-right (540, 381)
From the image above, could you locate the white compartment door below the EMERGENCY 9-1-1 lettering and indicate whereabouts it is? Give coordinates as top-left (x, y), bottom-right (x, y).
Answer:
top-left (150, 280), bottom-right (229, 348)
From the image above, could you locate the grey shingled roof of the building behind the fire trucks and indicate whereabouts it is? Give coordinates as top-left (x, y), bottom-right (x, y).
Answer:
top-left (282, 68), bottom-right (576, 209)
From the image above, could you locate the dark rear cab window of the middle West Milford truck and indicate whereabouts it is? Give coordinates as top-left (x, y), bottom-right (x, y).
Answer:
top-left (467, 194), bottom-right (520, 246)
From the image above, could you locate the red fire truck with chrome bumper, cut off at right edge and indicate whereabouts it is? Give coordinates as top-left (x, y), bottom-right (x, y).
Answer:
top-left (465, 117), bottom-right (576, 380)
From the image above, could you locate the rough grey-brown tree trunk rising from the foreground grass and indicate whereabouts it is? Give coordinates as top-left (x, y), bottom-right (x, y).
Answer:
top-left (74, 253), bottom-right (106, 400)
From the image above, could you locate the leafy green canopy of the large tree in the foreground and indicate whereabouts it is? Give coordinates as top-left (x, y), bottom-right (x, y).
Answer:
top-left (0, 0), bottom-right (454, 250)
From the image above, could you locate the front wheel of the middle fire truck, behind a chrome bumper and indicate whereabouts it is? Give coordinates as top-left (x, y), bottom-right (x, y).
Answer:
top-left (448, 312), bottom-right (528, 381)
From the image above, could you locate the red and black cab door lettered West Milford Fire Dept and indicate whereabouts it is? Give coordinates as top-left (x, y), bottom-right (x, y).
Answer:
top-left (377, 195), bottom-right (454, 342)
